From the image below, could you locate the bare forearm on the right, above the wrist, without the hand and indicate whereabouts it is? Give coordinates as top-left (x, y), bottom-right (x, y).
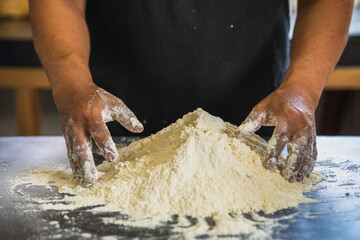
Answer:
top-left (282, 0), bottom-right (353, 108)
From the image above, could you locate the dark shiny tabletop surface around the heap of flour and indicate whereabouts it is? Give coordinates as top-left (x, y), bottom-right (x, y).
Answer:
top-left (0, 137), bottom-right (360, 239)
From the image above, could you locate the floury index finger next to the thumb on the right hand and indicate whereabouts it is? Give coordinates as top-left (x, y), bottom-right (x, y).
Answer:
top-left (265, 124), bottom-right (289, 170)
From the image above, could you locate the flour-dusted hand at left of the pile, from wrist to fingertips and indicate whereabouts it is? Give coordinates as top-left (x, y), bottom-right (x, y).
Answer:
top-left (54, 83), bottom-right (144, 187)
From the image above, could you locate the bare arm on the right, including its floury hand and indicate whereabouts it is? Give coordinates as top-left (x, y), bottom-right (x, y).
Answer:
top-left (237, 0), bottom-right (353, 182)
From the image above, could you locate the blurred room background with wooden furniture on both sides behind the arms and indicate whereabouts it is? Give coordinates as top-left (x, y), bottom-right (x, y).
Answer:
top-left (0, 0), bottom-right (360, 136)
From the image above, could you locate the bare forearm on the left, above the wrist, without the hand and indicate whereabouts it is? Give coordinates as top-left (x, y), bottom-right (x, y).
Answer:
top-left (29, 0), bottom-right (92, 94)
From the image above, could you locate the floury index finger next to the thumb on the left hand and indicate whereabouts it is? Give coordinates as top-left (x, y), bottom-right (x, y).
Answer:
top-left (89, 120), bottom-right (119, 162)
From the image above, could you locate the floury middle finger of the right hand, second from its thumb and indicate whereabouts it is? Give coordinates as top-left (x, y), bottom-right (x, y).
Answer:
top-left (282, 136), bottom-right (307, 182)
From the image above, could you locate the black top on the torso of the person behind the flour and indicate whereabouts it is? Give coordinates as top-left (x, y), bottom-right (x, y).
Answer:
top-left (87, 0), bottom-right (289, 135)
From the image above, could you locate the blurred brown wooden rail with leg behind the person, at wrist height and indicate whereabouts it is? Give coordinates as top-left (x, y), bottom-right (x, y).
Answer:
top-left (0, 67), bottom-right (360, 136)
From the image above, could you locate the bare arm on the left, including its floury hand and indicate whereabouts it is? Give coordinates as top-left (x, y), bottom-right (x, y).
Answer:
top-left (30, 0), bottom-right (143, 186)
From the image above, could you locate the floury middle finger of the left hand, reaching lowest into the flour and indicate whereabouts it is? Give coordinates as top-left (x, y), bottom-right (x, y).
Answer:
top-left (71, 127), bottom-right (98, 187)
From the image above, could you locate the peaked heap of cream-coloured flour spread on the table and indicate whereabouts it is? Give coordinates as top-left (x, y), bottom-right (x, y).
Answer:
top-left (28, 109), bottom-right (322, 237)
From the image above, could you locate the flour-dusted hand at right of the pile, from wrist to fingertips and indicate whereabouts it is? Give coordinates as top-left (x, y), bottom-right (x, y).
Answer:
top-left (235, 86), bottom-right (317, 182)
